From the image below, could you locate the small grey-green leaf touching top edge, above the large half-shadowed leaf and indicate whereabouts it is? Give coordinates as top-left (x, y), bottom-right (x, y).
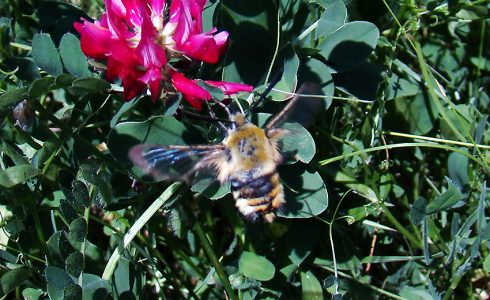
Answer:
top-left (315, 0), bottom-right (347, 39)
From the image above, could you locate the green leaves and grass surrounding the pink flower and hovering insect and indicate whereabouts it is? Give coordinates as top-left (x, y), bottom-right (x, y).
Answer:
top-left (0, 0), bottom-right (490, 299)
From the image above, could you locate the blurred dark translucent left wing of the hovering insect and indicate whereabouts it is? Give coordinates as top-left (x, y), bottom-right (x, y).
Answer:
top-left (128, 144), bottom-right (224, 182)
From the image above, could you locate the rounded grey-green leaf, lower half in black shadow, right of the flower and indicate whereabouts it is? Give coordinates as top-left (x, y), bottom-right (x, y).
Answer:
top-left (318, 21), bottom-right (379, 72)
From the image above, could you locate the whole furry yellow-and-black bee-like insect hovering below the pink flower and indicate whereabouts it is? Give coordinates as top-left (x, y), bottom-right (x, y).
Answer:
top-left (129, 88), bottom-right (308, 223)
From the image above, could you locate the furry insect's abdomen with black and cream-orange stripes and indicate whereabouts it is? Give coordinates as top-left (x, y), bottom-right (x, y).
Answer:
top-left (231, 172), bottom-right (285, 222)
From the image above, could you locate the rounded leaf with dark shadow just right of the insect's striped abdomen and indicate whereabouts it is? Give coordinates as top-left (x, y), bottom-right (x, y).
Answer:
top-left (278, 163), bottom-right (328, 218)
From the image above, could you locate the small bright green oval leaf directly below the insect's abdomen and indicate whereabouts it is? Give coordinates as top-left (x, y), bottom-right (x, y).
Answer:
top-left (238, 251), bottom-right (276, 281)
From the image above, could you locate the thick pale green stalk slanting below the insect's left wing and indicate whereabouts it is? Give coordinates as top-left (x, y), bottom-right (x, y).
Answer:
top-left (102, 182), bottom-right (182, 280)
